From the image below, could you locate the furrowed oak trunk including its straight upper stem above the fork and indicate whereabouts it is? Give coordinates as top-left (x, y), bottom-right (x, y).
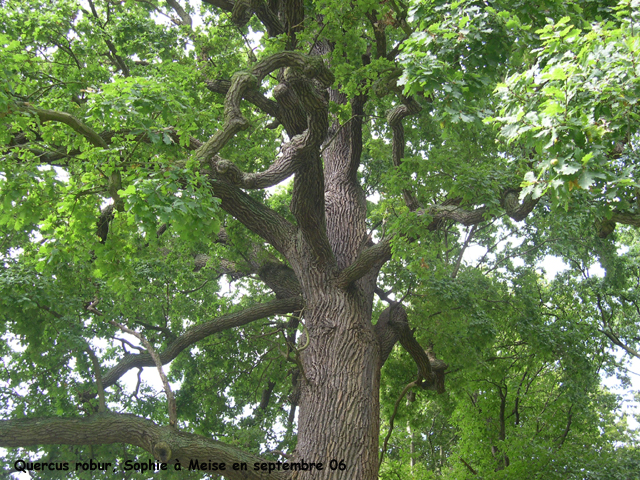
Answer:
top-left (294, 82), bottom-right (380, 480)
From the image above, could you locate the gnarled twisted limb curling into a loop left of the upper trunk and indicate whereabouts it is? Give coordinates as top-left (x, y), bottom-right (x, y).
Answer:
top-left (202, 52), bottom-right (333, 263)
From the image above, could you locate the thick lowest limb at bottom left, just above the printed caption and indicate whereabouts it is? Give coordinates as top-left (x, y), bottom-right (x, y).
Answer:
top-left (0, 412), bottom-right (289, 480)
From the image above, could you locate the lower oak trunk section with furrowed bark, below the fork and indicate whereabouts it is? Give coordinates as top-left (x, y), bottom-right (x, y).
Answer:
top-left (296, 287), bottom-right (380, 480)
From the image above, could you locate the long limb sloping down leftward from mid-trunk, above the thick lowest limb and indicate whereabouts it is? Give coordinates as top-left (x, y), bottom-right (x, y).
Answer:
top-left (102, 297), bottom-right (302, 388)
